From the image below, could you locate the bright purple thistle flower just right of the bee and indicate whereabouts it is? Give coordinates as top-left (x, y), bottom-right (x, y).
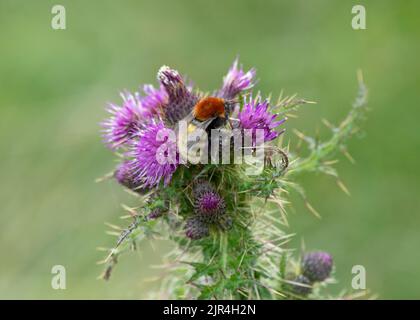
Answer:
top-left (238, 98), bottom-right (287, 141)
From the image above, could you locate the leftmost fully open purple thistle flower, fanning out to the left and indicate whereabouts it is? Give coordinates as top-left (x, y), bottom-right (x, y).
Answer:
top-left (102, 94), bottom-right (142, 149)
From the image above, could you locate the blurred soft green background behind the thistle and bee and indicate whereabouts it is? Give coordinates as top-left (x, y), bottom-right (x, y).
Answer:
top-left (0, 0), bottom-right (420, 299)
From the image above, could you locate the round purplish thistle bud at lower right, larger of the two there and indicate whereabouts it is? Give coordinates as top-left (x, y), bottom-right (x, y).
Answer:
top-left (301, 251), bottom-right (333, 282)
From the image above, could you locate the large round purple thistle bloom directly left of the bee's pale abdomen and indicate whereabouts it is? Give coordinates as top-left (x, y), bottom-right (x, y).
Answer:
top-left (128, 120), bottom-right (178, 187)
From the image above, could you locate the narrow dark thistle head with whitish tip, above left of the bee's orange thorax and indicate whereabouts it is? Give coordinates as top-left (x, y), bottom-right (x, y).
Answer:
top-left (157, 66), bottom-right (198, 125)
